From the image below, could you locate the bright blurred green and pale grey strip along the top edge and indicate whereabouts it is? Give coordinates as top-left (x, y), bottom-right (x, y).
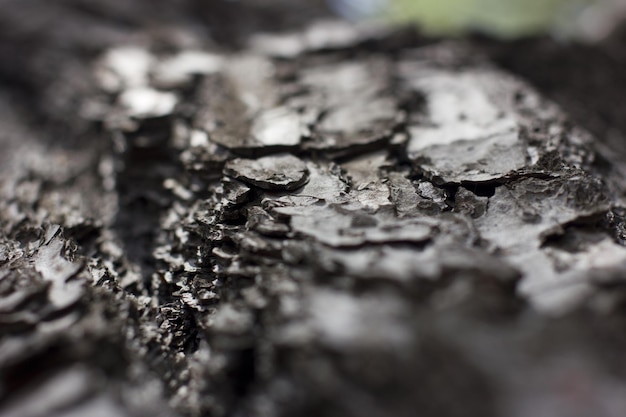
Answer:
top-left (331, 0), bottom-right (626, 40)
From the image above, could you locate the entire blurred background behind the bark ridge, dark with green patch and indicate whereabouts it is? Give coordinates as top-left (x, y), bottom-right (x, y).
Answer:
top-left (0, 0), bottom-right (626, 159)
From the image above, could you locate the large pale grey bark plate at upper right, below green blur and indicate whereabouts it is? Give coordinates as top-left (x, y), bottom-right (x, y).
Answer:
top-left (399, 47), bottom-right (560, 184)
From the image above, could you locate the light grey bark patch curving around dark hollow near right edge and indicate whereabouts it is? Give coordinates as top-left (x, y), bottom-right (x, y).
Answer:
top-left (476, 173), bottom-right (622, 312)
